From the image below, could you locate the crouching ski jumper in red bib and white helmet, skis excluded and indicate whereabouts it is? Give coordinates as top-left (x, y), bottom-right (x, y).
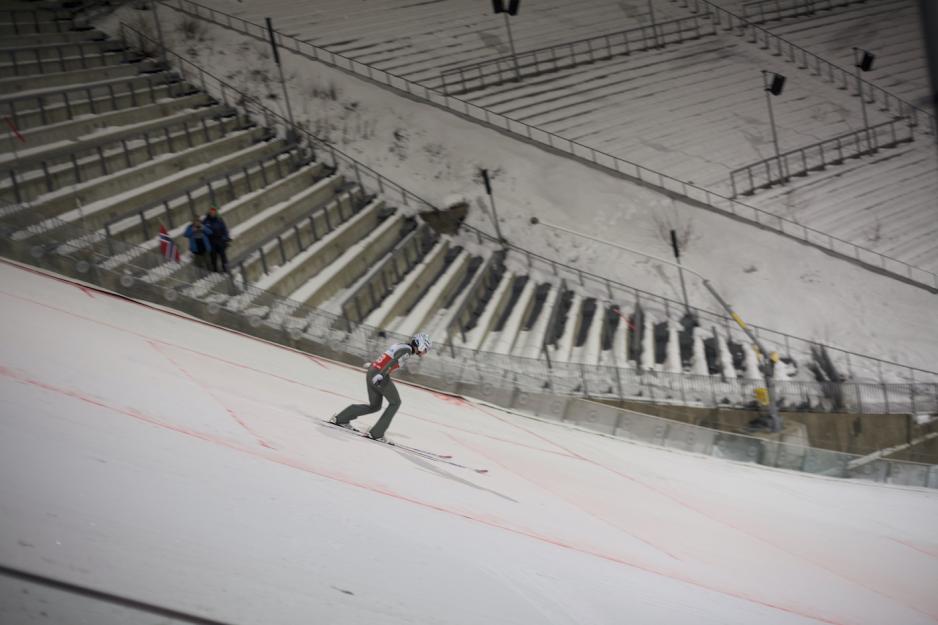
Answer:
top-left (330, 332), bottom-right (432, 441)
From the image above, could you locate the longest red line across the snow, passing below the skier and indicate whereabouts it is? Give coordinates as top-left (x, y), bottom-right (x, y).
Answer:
top-left (0, 365), bottom-right (844, 625)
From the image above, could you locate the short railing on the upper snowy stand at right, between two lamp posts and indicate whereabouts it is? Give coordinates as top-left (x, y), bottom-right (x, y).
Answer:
top-left (730, 120), bottom-right (915, 198)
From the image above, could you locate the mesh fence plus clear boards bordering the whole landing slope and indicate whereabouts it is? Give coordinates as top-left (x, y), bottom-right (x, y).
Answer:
top-left (0, 221), bottom-right (938, 487)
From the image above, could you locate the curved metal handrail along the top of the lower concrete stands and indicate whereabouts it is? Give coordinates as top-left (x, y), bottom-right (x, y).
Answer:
top-left (113, 19), bottom-right (938, 379)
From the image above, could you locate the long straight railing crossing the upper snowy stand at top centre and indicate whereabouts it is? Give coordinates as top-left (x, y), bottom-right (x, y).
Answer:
top-left (440, 15), bottom-right (717, 95)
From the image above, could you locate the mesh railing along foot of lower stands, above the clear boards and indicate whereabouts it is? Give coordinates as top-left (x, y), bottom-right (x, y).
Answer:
top-left (7, 205), bottom-right (938, 424)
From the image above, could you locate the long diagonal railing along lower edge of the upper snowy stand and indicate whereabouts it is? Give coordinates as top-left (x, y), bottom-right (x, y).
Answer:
top-left (164, 0), bottom-right (938, 293)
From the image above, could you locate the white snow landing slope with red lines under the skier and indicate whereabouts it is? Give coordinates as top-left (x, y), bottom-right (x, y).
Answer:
top-left (0, 262), bottom-right (938, 625)
